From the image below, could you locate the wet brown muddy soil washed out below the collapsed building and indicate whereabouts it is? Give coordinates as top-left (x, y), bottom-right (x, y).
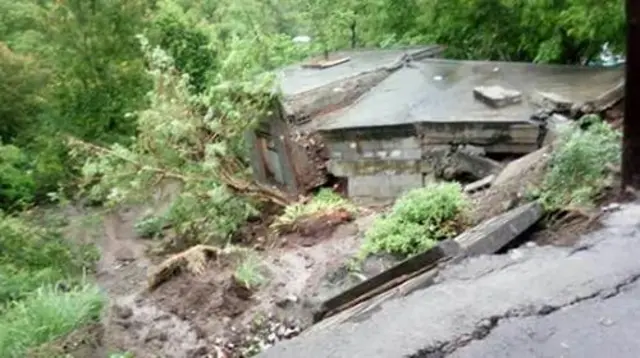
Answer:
top-left (52, 203), bottom-right (382, 358)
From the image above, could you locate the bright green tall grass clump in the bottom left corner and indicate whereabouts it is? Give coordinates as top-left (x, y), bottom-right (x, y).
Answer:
top-left (0, 285), bottom-right (105, 358)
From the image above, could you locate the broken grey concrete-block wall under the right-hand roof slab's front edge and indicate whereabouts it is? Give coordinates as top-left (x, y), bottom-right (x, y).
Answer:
top-left (323, 121), bottom-right (541, 200)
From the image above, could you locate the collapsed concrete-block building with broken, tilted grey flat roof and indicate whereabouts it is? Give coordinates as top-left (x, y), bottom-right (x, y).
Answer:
top-left (246, 47), bottom-right (624, 199)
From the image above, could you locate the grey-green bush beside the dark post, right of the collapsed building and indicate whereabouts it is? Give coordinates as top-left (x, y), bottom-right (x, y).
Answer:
top-left (540, 116), bottom-right (621, 211)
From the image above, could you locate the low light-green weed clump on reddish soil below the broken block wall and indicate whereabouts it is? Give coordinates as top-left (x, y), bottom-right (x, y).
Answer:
top-left (271, 189), bottom-right (357, 233)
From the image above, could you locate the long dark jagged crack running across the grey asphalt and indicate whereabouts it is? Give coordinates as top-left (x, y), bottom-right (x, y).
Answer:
top-left (407, 273), bottom-right (640, 358)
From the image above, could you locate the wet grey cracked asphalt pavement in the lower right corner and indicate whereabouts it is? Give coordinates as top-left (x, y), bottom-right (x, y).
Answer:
top-left (259, 203), bottom-right (640, 358)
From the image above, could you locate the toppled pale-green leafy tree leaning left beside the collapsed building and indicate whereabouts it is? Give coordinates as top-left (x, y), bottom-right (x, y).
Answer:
top-left (68, 38), bottom-right (293, 249)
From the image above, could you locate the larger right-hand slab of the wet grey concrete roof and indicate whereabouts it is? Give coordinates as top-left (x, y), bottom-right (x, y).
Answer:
top-left (318, 59), bottom-right (624, 131)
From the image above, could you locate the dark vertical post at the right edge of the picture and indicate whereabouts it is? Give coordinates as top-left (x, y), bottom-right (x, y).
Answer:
top-left (622, 0), bottom-right (640, 190)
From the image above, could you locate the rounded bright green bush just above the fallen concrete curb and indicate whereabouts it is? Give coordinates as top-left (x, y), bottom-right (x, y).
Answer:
top-left (360, 183), bottom-right (467, 258)
